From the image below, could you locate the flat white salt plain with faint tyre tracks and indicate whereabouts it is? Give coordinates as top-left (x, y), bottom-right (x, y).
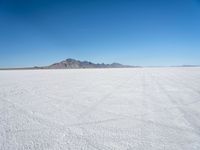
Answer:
top-left (0, 68), bottom-right (200, 150)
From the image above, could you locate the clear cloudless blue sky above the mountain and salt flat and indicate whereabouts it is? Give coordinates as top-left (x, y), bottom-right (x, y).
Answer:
top-left (0, 0), bottom-right (200, 67)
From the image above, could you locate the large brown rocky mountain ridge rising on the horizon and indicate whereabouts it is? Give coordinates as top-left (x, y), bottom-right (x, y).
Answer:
top-left (44, 58), bottom-right (133, 69)
